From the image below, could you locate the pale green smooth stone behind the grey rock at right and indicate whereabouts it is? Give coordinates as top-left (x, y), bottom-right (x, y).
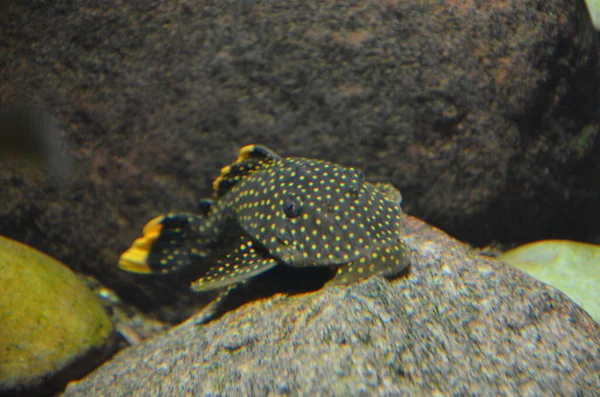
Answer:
top-left (499, 240), bottom-right (600, 322)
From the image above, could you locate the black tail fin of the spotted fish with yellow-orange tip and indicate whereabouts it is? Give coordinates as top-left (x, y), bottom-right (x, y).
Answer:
top-left (119, 213), bottom-right (210, 274)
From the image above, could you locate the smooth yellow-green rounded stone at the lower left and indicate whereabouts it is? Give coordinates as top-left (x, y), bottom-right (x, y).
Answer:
top-left (0, 236), bottom-right (112, 395)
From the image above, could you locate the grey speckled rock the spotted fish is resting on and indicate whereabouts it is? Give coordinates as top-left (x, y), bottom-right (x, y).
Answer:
top-left (58, 218), bottom-right (600, 397)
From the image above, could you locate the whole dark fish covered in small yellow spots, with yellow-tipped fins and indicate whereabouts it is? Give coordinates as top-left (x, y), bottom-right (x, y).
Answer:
top-left (119, 145), bottom-right (409, 291)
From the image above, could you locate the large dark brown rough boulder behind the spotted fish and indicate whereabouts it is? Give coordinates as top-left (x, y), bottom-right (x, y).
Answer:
top-left (0, 0), bottom-right (600, 306)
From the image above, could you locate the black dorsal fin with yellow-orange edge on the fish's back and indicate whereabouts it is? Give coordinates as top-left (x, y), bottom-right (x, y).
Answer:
top-left (213, 145), bottom-right (281, 197)
